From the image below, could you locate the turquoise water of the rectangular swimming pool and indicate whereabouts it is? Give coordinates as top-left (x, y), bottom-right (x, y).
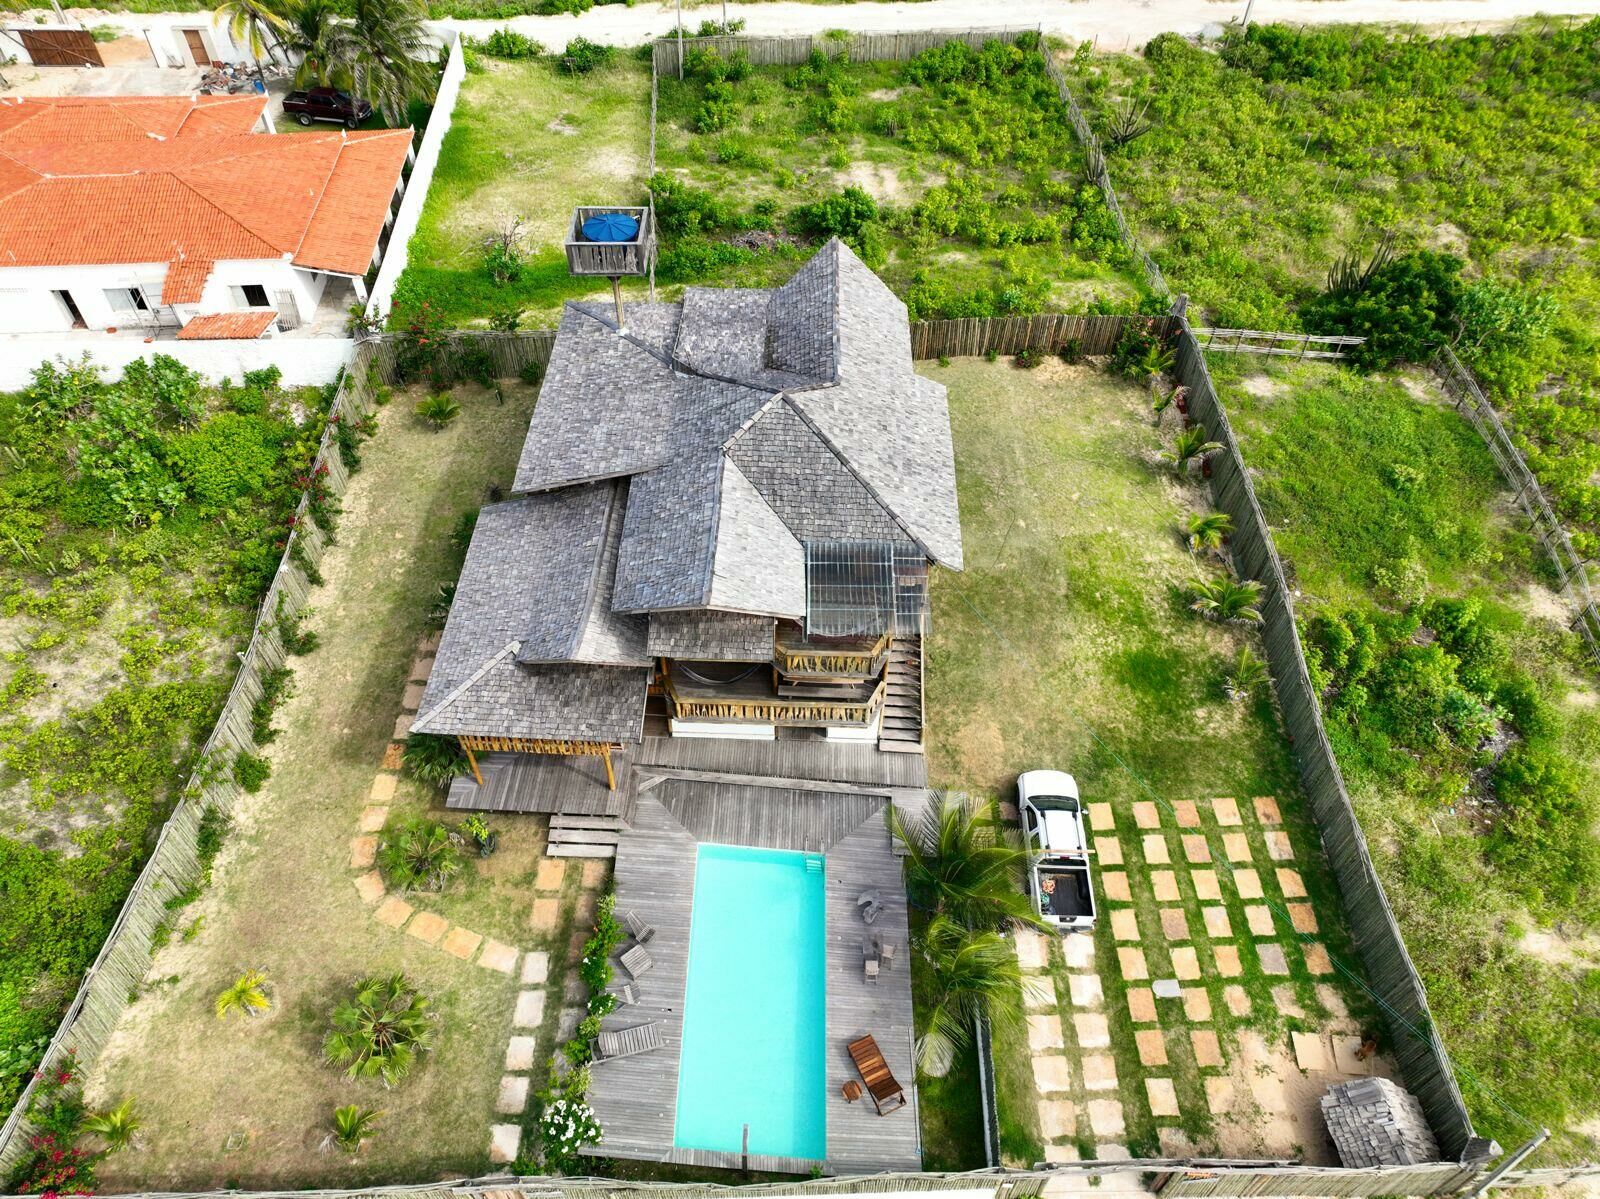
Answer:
top-left (674, 845), bottom-right (827, 1161)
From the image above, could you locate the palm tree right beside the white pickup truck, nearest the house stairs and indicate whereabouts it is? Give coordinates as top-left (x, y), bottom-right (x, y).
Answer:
top-left (888, 791), bottom-right (1040, 928)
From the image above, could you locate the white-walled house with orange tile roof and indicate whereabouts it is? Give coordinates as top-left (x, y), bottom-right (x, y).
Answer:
top-left (0, 96), bottom-right (411, 338)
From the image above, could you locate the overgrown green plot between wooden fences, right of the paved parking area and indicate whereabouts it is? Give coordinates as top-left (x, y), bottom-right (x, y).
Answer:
top-left (1213, 355), bottom-right (1600, 1143)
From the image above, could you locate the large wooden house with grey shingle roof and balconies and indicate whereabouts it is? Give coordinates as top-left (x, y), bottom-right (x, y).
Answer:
top-left (411, 240), bottom-right (962, 790)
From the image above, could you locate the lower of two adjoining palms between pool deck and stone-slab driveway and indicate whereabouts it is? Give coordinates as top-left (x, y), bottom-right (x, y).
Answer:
top-left (917, 916), bottom-right (1022, 1077)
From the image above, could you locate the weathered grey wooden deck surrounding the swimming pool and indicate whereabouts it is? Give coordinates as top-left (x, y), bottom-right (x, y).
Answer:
top-left (590, 771), bottom-right (922, 1173)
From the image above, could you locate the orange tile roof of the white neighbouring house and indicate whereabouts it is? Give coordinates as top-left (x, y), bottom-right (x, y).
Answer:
top-left (0, 96), bottom-right (411, 278)
